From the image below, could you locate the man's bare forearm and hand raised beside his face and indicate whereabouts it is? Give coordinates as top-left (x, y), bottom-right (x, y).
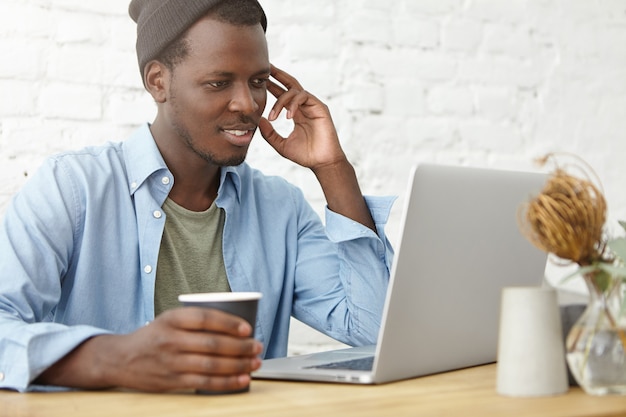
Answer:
top-left (259, 67), bottom-right (375, 231)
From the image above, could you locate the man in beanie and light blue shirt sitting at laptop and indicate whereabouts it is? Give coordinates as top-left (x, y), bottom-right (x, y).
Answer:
top-left (0, 0), bottom-right (392, 391)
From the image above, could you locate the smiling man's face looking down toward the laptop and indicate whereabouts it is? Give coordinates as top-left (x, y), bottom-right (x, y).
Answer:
top-left (162, 18), bottom-right (270, 166)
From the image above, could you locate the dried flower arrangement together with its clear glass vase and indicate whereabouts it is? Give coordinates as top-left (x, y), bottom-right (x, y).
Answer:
top-left (518, 154), bottom-right (626, 395)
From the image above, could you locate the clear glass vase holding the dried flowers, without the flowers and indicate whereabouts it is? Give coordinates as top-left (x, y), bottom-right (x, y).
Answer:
top-left (565, 274), bottom-right (626, 395)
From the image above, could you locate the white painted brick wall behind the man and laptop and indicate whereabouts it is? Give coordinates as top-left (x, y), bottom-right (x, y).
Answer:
top-left (0, 0), bottom-right (626, 351)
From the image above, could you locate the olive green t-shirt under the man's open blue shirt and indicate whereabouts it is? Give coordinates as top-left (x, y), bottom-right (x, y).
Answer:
top-left (154, 198), bottom-right (230, 316)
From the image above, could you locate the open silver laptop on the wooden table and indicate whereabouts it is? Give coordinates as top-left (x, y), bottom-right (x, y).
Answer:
top-left (253, 164), bottom-right (546, 384)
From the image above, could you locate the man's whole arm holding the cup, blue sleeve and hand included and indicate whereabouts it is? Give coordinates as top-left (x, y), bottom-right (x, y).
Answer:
top-left (0, 157), bottom-right (261, 391)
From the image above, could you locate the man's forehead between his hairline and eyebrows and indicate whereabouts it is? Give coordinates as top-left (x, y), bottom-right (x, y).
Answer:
top-left (180, 17), bottom-right (269, 71)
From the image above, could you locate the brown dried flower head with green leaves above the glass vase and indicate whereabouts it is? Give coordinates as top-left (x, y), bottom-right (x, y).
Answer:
top-left (518, 154), bottom-right (626, 291)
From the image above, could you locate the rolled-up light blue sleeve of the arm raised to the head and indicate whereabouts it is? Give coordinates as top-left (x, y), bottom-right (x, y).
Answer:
top-left (294, 193), bottom-right (396, 346)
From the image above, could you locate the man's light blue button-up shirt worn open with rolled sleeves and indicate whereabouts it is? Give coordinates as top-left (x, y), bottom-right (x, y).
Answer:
top-left (0, 124), bottom-right (393, 391)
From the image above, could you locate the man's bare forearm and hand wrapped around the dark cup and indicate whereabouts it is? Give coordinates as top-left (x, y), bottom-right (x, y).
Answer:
top-left (35, 308), bottom-right (262, 391)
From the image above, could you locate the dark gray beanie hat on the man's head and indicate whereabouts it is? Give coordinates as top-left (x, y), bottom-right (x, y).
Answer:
top-left (128, 0), bottom-right (267, 79)
